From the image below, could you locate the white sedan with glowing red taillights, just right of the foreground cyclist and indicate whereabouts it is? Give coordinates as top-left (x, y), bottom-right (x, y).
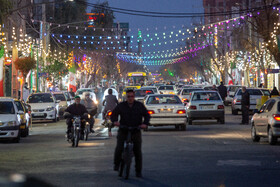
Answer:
top-left (144, 94), bottom-right (187, 130)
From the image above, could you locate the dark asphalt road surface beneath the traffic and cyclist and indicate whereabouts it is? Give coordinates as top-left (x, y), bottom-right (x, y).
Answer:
top-left (0, 108), bottom-right (280, 187)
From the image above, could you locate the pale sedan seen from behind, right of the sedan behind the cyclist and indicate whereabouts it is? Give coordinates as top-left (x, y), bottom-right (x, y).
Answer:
top-left (187, 90), bottom-right (225, 125)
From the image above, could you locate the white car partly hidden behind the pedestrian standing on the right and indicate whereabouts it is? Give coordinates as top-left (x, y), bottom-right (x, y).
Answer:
top-left (231, 88), bottom-right (264, 115)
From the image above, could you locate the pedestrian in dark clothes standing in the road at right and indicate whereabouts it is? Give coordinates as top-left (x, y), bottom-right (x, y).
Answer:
top-left (241, 86), bottom-right (250, 125)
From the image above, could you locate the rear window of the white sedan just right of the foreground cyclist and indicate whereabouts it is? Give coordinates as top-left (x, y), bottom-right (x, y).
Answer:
top-left (147, 95), bottom-right (182, 104)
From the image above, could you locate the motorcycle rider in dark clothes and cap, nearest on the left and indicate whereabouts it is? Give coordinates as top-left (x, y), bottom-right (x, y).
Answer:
top-left (64, 96), bottom-right (87, 139)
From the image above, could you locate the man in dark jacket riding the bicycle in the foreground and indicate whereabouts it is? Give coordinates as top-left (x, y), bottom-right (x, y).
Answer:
top-left (111, 90), bottom-right (150, 177)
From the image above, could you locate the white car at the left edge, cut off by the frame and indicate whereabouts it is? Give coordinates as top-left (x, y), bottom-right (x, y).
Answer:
top-left (0, 97), bottom-right (23, 143)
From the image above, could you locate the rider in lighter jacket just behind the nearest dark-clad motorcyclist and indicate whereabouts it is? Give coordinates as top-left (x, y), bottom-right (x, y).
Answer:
top-left (81, 92), bottom-right (97, 133)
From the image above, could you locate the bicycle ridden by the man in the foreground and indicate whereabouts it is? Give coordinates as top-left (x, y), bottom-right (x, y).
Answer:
top-left (119, 127), bottom-right (140, 179)
